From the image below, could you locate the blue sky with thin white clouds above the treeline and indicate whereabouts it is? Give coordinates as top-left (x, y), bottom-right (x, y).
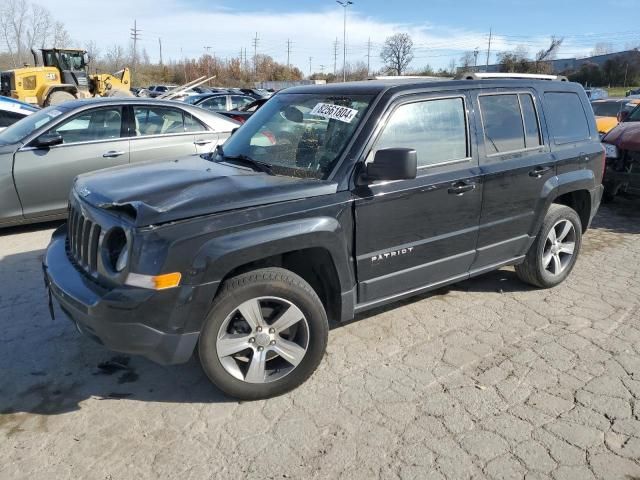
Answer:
top-left (42, 0), bottom-right (640, 73)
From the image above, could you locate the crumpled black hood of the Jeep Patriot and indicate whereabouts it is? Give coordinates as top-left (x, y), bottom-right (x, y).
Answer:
top-left (74, 156), bottom-right (337, 226)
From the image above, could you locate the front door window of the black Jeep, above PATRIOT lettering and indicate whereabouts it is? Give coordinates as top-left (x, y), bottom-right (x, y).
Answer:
top-left (374, 98), bottom-right (468, 167)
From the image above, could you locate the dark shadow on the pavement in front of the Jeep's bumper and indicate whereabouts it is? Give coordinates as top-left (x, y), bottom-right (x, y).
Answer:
top-left (0, 249), bottom-right (235, 420)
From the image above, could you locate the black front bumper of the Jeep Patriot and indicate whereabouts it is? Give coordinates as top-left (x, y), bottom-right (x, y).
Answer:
top-left (43, 225), bottom-right (217, 365)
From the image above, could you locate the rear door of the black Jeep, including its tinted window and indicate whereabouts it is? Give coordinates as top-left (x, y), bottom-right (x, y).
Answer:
top-left (472, 89), bottom-right (556, 273)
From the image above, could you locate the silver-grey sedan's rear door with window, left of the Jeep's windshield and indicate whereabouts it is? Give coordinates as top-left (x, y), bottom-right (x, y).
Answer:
top-left (131, 105), bottom-right (208, 163)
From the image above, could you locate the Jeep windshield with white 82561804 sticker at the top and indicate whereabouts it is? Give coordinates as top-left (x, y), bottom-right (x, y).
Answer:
top-left (216, 93), bottom-right (373, 179)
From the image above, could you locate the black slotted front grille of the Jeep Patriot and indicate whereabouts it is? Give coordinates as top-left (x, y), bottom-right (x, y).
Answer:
top-left (67, 207), bottom-right (102, 275)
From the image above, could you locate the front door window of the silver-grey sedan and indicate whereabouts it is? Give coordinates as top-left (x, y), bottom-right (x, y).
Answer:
top-left (48, 107), bottom-right (122, 143)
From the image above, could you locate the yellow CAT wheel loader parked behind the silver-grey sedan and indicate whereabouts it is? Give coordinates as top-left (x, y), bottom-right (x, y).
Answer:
top-left (0, 48), bottom-right (131, 107)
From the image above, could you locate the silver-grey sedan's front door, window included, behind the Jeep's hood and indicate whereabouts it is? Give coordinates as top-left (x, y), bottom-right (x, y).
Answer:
top-left (13, 106), bottom-right (129, 218)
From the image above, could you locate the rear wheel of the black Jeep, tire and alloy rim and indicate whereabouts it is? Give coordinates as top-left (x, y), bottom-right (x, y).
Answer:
top-left (515, 203), bottom-right (582, 288)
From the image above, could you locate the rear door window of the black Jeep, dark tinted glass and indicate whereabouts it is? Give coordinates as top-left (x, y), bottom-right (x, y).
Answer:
top-left (479, 93), bottom-right (541, 155)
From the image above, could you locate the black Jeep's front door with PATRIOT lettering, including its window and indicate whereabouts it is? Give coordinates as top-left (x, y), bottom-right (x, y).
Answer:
top-left (354, 93), bottom-right (482, 306)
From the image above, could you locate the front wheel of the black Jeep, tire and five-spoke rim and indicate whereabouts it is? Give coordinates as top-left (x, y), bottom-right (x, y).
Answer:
top-left (198, 268), bottom-right (329, 400)
